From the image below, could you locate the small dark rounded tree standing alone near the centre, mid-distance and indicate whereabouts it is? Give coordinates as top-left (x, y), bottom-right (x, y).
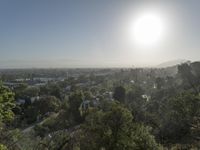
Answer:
top-left (113, 86), bottom-right (126, 103)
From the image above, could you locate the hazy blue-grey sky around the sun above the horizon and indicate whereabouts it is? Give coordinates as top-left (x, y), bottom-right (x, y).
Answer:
top-left (0, 0), bottom-right (200, 68)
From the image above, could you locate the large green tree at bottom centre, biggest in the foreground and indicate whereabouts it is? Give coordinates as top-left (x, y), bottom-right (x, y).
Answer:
top-left (80, 103), bottom-right (159, 150)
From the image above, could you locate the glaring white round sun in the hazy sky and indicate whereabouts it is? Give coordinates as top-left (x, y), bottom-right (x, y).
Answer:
top-left (131, 13), bottom-right (164, 46)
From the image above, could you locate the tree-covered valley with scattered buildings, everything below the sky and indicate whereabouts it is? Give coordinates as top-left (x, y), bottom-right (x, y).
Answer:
top-left (0, 62), bottom-right (200, 150)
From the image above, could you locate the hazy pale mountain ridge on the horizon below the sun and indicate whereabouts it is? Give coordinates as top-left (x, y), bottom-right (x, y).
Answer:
top-left (156, 59), bottom-right (190, 68)
